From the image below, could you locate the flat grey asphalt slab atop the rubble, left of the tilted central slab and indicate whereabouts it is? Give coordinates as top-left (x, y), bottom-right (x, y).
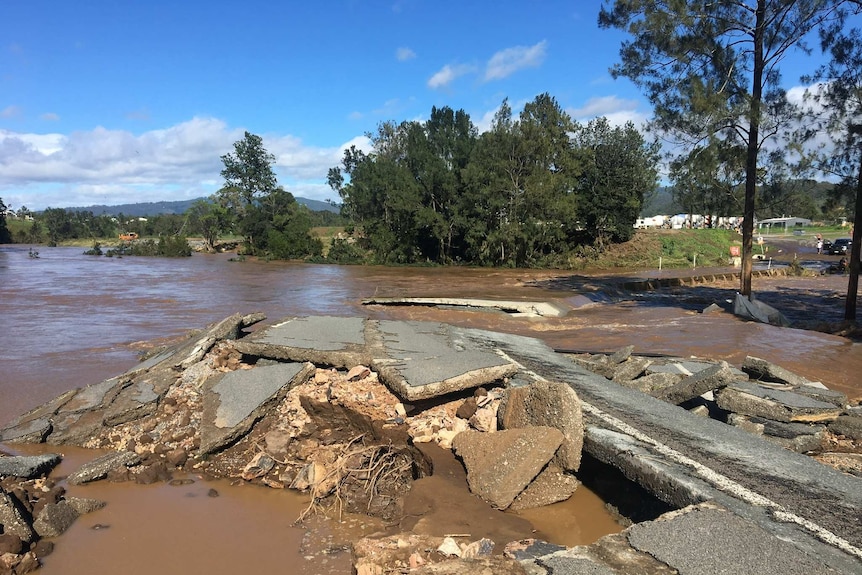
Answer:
top-left (233, 316), bottom-right (370, 368)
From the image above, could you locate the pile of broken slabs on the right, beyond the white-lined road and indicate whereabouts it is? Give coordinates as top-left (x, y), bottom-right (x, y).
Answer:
top-left (570, 346), bottom-right (862, 477)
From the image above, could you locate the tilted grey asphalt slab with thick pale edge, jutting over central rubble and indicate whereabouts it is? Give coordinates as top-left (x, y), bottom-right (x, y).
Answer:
top-left (371, 321), bottom-right (518, 401)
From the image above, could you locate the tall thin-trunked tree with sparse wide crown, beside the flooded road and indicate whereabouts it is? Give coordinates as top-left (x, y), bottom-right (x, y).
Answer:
top-left (599, 0), bottom-right (843, 296)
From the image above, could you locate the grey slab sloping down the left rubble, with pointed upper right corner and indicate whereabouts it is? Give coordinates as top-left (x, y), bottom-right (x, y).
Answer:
top-left (200, 363), bottom-right (314, 454)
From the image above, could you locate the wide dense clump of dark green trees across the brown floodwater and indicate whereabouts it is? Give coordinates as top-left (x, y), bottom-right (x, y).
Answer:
top-left (328, 94), bottom-right (658, 267)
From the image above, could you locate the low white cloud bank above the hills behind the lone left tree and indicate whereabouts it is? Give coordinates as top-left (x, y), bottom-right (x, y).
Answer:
top-left (0, 118), bottom-right (370, 210)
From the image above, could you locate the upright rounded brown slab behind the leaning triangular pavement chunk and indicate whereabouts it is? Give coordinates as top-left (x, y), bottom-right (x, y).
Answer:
top-left (497, 380), bottom-right (584, 471)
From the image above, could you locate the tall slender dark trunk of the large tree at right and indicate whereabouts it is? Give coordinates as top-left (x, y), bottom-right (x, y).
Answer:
top-left (739, 0), bottom-right (766, 299)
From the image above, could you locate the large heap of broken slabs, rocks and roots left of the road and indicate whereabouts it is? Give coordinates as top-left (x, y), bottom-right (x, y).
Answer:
top-left (0, 314), bottom-right (583, 575)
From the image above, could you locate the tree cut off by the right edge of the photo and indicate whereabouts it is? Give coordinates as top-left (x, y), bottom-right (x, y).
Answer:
top-left (803, 12), bottom-right (862, 320)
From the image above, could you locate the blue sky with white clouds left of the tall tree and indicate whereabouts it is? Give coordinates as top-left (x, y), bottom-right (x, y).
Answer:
top-left (0, 0), bottom-right (836, 210)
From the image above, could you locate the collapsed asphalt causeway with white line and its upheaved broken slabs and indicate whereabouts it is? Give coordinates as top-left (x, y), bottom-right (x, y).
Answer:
top-left (0, 315), bottom-right (862, 574)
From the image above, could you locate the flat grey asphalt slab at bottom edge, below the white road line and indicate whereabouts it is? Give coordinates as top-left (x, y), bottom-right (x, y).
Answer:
top-left (628, 504), bottom-right (835, 575)
